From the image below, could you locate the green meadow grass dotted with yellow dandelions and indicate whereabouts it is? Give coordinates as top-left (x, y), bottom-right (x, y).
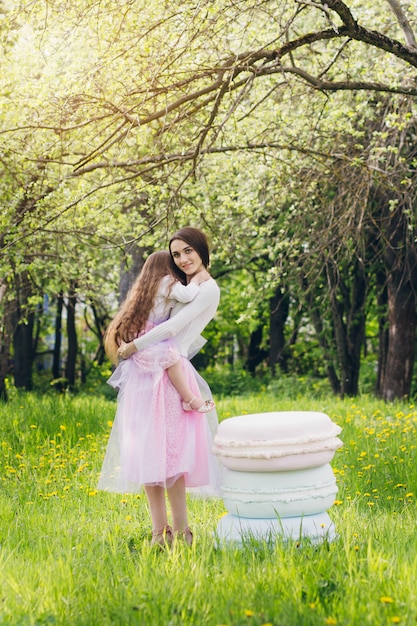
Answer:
top-left (0, 390), bottom-right (417, 626)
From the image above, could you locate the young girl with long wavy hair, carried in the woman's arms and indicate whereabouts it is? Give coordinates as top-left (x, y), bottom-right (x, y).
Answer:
top-left (104, 250), bottom-right (214, 413)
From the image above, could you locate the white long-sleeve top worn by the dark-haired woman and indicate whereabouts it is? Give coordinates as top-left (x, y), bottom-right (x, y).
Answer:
top-left (134, 278), bottom-right (220, 358)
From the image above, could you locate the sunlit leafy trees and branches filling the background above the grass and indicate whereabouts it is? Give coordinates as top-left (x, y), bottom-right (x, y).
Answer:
top-left (0, 0), bottom-right (417, 400)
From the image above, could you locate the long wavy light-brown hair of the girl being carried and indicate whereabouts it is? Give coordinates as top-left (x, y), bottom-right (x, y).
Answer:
top-left (104, 250), bottom-right (177, 364)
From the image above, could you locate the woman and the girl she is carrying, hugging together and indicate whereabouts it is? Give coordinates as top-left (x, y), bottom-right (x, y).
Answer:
top-left (98, 227), bottom-right (220, 546)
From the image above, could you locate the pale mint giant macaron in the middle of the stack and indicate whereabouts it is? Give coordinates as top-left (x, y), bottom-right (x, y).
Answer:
top-left (220, 464), bottom-right (337, 518)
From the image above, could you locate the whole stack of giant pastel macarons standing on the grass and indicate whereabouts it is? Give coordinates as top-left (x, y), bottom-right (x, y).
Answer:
top-left (214, 411), bottom-right (342, 543)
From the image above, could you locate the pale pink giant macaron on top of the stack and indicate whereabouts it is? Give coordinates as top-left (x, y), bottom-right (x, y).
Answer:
top-left (214, 411), bottom-right (342, 472)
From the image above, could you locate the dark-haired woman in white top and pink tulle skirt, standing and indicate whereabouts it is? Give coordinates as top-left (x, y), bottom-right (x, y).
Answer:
top-left (99, 227), bottom-right (220, 545)
